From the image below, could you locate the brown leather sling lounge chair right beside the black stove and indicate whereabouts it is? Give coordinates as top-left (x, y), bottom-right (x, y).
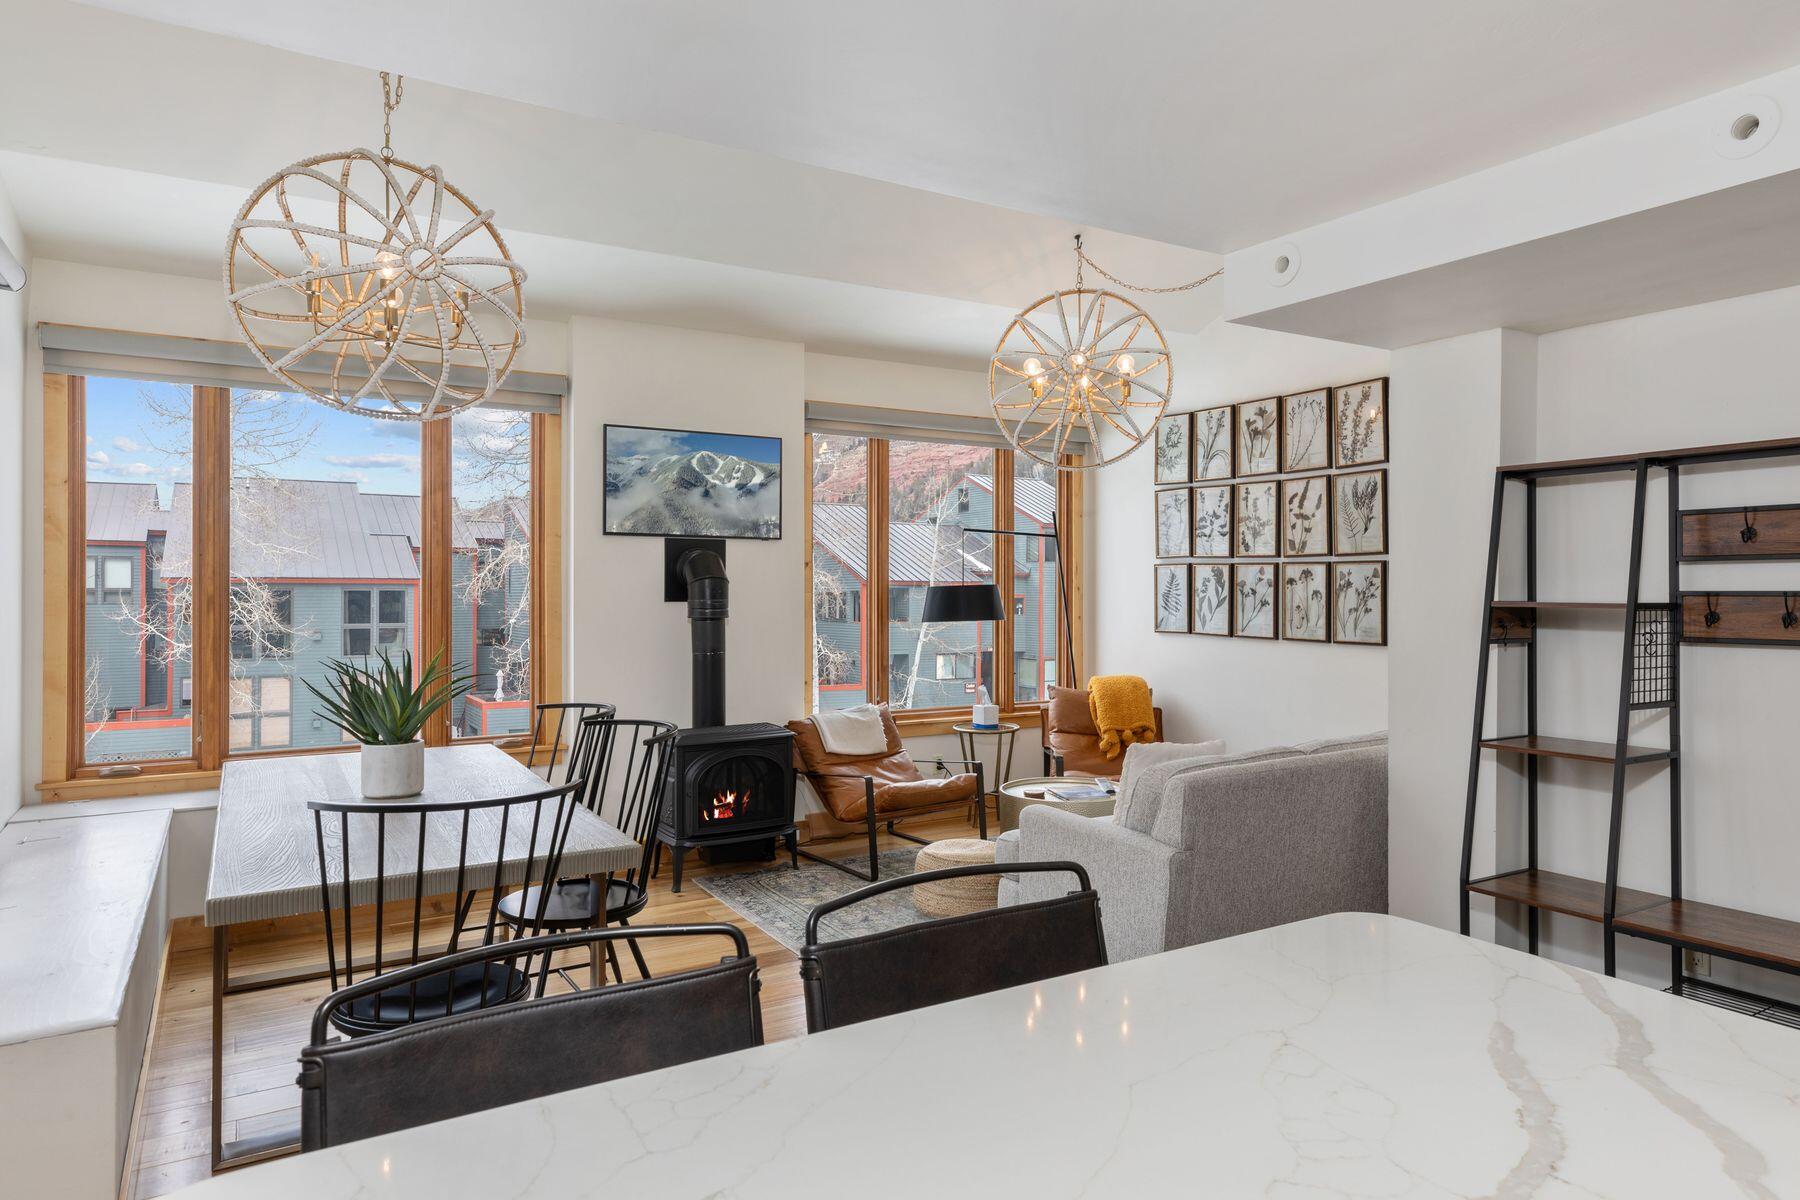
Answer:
top-left (788, 703), bottom-right (988, 883)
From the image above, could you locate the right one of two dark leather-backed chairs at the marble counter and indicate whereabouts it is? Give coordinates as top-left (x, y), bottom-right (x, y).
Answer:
top-left (799, 862), bottom-right (1107, 1033)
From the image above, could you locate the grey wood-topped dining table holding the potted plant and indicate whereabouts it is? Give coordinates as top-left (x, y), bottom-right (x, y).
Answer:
top-left (205, 743), bottom-right (643, 1171)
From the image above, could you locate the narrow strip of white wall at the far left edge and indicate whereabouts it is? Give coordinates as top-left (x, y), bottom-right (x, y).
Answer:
top-left (0, 187), bottom-right (25, 824)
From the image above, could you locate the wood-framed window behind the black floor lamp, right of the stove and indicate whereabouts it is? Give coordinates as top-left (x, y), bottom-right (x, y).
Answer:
top-left (808, 434), bottom-right (1073, 712)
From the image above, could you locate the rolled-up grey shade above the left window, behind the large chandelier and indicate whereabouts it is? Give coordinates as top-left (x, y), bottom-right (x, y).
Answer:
top-left (38, 324), bottom-right (569, 412)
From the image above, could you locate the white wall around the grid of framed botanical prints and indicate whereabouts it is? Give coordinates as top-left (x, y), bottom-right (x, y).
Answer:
top-left (1087, 322), bottom-right (1389, 750)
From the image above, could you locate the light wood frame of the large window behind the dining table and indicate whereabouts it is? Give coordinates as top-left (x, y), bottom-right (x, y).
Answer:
top-left (38, 372), bottom-right (563, 802)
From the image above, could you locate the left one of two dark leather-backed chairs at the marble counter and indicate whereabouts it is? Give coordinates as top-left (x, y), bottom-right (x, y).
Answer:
top-left (299, 925), bottom-right (763, 1150)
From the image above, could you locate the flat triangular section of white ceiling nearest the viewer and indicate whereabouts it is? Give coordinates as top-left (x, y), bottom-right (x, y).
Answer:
top-left (77, 0), bottom-right (1800, 252)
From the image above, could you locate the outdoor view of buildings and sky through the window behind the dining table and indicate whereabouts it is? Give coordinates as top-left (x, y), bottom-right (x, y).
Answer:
top-left (85, 378), bottom-right (531, 763)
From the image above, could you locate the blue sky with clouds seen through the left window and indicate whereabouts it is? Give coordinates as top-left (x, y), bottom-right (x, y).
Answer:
top-left (86, 376), bottom-right (525, 504)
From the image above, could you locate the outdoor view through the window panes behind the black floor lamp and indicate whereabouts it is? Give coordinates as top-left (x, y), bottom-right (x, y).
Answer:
top-left (812, 435), bottom-right (1060, 709)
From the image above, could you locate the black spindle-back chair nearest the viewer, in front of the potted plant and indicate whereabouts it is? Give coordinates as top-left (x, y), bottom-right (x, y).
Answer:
top-left (306, 779), bottom-right (587, 1036)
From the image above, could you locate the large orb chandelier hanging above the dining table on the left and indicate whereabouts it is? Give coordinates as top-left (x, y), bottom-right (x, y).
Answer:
top-left (225, 70), bottom-right (526, 421)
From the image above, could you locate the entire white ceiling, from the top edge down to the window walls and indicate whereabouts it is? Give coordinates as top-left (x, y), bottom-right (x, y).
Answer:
top-left (10, 0), bottom-right (1800, 367)
